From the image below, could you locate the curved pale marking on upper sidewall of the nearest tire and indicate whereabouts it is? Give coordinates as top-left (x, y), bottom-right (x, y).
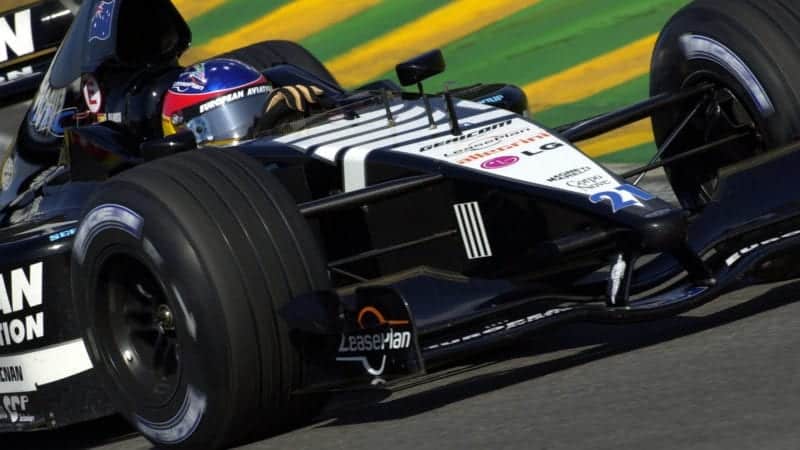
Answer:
top-left (72, 204), bottom-right (144, 263)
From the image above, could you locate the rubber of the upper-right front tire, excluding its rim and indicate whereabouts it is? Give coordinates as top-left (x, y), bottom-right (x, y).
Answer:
top-left (650, 2), bottom-right (800, 205)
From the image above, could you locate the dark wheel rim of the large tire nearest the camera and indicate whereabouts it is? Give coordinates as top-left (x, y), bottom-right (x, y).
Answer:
top-left (95, 254), bottom-right (182, 408)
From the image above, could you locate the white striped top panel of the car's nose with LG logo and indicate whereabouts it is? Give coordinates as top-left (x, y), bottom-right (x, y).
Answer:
top-left (278, 98), bottom-right (620, 200)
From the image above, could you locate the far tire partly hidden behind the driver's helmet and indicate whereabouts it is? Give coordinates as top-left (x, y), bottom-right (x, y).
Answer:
top-left (220, 41), bottom-right (339, 86)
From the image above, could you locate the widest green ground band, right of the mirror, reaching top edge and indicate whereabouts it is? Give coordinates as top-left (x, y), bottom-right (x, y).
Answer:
top-left (374, 0), bottom-right (687, 85)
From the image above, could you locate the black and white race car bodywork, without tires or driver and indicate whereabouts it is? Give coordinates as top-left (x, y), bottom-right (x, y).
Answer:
top-left (0, 0), bottom-right (800, 431)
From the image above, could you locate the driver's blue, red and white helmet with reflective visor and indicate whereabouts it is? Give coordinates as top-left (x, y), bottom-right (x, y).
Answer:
top-left (162, 58), bottom-right (272, 146)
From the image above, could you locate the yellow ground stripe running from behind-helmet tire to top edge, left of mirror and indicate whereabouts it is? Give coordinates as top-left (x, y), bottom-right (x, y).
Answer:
top-left (326, 0), bottom-right (539, 87)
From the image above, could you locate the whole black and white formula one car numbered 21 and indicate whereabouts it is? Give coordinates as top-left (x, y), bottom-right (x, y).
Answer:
top-left (0, 0), bottom-right (800, 449)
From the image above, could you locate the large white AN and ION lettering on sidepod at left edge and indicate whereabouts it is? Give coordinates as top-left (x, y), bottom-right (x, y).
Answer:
top-left (0, 262), bottom-right (44, 348)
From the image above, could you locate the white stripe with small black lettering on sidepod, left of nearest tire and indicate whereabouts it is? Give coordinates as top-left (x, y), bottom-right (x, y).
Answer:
top-left (0, 339), bottom-right (92, 394)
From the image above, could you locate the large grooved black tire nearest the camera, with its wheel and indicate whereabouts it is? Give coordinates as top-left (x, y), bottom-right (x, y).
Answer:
top-left (72, 150), bottom-right (329, 449)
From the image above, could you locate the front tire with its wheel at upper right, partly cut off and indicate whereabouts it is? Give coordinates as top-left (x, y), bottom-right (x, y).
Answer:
top-left (650, 0), bottom-right (800, 209)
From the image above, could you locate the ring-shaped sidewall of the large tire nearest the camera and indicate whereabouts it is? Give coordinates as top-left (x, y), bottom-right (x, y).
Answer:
top-left (72, 184), bottom-right (238, 447)
